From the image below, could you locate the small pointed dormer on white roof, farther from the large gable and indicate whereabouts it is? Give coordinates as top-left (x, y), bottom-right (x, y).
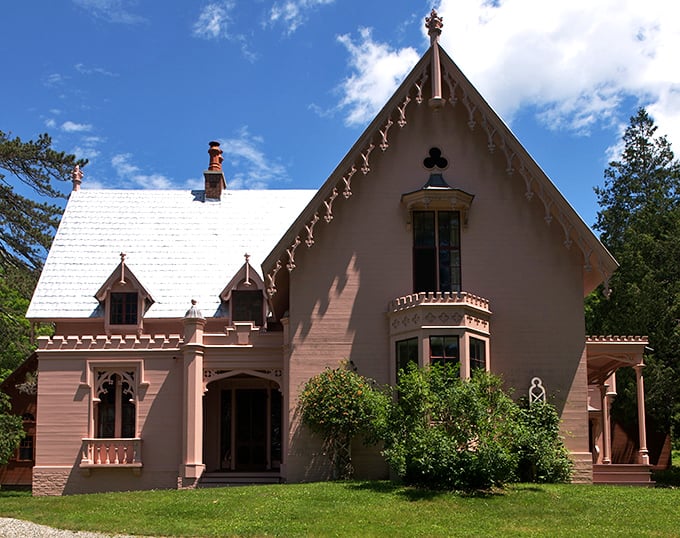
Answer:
top-left (95, 253), bottom-right (154, 335)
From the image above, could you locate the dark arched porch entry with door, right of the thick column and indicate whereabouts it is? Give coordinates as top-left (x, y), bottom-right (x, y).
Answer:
top-left (203, 370), bottom-right (282, 473)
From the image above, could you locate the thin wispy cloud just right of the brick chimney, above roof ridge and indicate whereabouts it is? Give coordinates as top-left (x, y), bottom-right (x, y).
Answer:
top-left (220, 127), bottom-right (289, 189)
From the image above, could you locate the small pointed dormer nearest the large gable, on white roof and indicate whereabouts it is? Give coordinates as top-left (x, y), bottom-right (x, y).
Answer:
top-left (220, 254), bottom-right (268, 327)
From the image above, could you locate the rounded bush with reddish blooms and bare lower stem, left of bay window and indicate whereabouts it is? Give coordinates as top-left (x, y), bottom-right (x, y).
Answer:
top-left (300, 363), bottom-right (387, 479)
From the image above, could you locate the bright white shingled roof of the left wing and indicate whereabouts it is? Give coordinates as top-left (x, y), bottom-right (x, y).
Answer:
top-left (26, 189), bottom-right (316, 319)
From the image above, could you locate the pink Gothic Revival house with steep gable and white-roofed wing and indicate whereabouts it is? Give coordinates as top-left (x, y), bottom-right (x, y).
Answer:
top-left (28, 12), bottom-right (649, 495)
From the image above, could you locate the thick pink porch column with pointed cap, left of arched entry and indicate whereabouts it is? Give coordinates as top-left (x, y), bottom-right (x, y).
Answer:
top-left (180, 301), bottom-right (205, 480)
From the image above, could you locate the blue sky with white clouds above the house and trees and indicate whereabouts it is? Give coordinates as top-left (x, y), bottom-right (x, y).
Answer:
top-left (0, 0), bottom-right (680, 225)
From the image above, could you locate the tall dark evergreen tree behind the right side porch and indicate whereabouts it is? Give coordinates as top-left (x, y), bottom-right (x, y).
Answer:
top-left (586, 108), bottom-right (680, 440)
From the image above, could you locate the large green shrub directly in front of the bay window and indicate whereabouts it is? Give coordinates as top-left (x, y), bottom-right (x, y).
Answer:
top-left (383, 366), bottom-right (518, 490)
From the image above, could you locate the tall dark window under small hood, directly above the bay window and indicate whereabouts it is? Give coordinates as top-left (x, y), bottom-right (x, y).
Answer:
top-left (413, 211), bottom-right (461, 292)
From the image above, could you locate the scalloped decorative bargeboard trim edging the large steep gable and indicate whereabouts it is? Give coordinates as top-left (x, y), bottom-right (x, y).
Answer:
top-left (263, 40), bottom-right (617, 297)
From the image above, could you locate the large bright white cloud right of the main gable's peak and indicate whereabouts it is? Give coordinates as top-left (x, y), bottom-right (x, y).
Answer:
top-left (437, 0), bottom-right (680, 143)
